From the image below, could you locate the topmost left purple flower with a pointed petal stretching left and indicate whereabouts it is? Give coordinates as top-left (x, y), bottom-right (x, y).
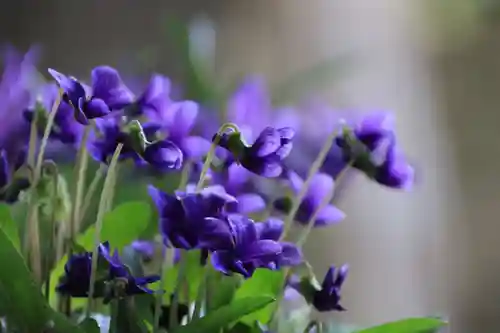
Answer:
top-left (49, 66), bottom-right (133, 125)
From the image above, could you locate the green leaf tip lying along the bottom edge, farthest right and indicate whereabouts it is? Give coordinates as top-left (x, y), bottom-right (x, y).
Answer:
top-left (355, 318), bottom-right (447, 333)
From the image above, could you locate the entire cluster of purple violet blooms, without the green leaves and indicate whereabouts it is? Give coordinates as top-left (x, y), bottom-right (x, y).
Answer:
top-left (0, 47), bottom-right (414, 332)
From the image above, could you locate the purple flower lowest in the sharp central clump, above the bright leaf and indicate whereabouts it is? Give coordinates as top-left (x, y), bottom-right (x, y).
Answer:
top-left (211, 214), bottom-right (283, 278)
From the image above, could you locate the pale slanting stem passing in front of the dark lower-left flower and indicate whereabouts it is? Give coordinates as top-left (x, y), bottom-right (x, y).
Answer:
top-left (85, 143), bottom-right (123, 318)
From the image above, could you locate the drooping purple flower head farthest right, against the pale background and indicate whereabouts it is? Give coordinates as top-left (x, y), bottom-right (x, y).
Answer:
top-left (336, 113), bottom-right (414, 189)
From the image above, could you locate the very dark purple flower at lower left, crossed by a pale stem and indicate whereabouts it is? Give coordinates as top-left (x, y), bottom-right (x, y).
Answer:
top-left (56, 242), bottom-right (160, 298)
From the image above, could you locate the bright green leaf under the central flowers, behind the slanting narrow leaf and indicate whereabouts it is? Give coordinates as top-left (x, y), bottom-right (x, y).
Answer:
top-left (235, 268), bottom-right (284, 324)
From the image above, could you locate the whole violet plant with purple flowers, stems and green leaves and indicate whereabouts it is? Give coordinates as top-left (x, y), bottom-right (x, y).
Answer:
top-left (0, 43), bottom-right (444, 333)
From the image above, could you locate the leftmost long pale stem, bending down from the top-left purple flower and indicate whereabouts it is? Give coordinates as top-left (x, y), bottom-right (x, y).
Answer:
top-left (26, 90), bottom-right (62, 283)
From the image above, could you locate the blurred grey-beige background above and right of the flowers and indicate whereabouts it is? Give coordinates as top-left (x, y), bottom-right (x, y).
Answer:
top-left (0, 0), bottom-right (500, 333)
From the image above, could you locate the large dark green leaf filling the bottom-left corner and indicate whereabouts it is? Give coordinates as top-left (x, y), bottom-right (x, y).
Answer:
top-left (0, 226), bottom-right (84, 333)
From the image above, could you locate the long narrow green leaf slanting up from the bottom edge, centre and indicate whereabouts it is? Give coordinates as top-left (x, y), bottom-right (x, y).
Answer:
top-left (173, 296), bottom-right (275, 333)
